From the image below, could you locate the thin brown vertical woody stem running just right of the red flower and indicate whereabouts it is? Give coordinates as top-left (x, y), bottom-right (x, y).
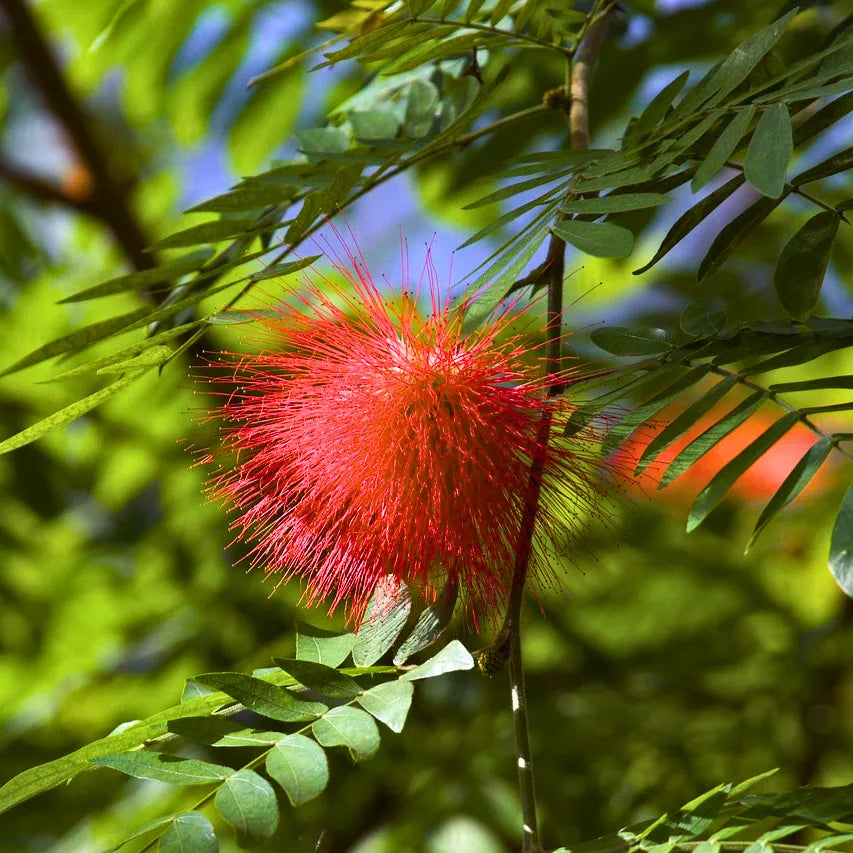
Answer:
top-left (498, 0), bottom-right (612, 853)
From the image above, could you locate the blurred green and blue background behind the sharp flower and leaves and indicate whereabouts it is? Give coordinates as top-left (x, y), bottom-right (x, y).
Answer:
top-left (0, 0), bottom-right (853, 853)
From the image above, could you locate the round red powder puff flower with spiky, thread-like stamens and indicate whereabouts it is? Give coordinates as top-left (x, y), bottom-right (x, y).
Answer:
top-left (201, 243), bottom-right (612, 622)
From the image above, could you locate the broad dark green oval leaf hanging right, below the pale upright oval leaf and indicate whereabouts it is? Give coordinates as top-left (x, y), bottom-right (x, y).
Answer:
top-left (773, 211), bottom-right (841, 320)
